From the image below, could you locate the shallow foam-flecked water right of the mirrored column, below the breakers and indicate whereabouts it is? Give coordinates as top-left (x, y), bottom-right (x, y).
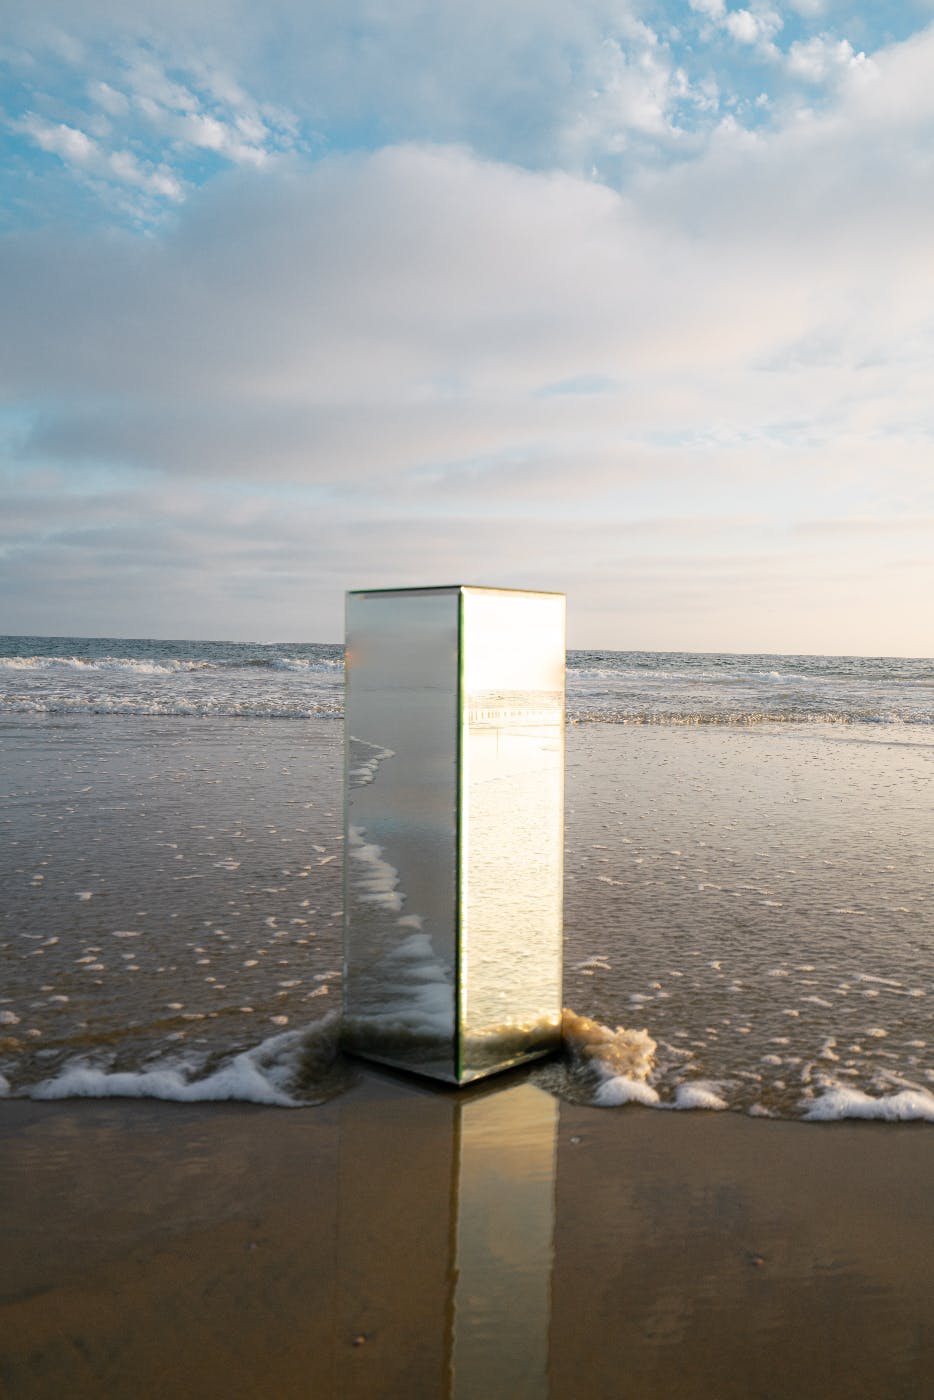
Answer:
top-left (554, 727), bottom-right (934, 1116)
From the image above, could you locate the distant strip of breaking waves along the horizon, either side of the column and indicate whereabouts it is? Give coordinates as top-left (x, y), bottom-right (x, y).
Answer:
top-left (0, 637), bottom-right (934, 728)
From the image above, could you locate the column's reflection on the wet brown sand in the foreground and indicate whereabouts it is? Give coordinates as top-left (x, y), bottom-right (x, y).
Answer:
top-left (336, 1077), bottom-right (557, 1400)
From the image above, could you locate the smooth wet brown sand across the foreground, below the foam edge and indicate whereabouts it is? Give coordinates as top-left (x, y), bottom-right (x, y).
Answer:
top-left (0, 1068), bottom-right (934, 1400)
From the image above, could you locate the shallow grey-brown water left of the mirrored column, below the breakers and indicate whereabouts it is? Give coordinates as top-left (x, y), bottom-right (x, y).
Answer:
top-left (0, 717), bottom-right (342, 1091)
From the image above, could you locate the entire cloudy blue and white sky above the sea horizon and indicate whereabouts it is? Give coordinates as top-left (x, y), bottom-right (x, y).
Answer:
top-left (0, 0), bottom-right (934, 657)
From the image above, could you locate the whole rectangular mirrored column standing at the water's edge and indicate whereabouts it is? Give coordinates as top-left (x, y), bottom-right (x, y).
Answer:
top-left (344, 588), bottom-right (564, 1082)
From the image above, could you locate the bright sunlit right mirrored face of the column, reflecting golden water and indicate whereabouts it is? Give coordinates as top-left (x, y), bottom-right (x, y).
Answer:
top-left (459, 588), bottom-right (564, 1081)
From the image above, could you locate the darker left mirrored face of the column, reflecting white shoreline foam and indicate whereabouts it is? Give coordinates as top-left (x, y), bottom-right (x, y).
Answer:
top-left (343, 589), bottom-right (459, 1081)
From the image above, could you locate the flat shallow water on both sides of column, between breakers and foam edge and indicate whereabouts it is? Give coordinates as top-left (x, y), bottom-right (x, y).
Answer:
top-left (0, 715), bottom-right (934, 1117)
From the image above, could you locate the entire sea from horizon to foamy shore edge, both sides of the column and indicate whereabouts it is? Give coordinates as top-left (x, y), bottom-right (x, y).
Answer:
top-left (0, 637), bottom-right (934, 1121)
